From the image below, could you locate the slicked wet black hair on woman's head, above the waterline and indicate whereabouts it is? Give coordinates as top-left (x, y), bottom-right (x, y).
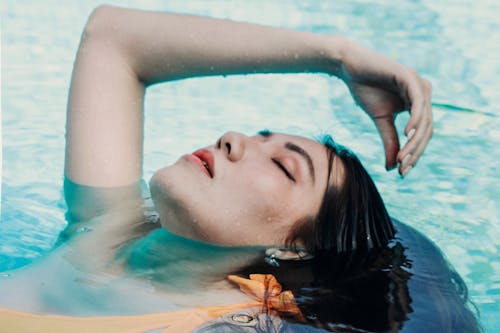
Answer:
top-left (286, 135), bottom-right (394, 254)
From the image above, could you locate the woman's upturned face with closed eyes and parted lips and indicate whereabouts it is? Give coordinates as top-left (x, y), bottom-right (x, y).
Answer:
top-left (150, 132), bottom-right (340, 245)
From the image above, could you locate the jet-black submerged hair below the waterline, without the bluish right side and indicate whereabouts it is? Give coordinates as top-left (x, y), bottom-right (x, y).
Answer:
top-left (237, 243), bottom-right (412, 333)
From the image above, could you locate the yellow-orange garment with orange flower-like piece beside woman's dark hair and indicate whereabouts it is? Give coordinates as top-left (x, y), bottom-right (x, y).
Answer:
top-left (0, 274), bottom-right (303, 333)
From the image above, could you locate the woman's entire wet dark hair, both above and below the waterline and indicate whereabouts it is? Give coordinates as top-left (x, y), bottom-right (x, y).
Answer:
top-left (235, 136), bottom-right (481, 333)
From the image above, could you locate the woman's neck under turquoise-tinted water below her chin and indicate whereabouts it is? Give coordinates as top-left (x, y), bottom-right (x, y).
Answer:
top-left (119, 228), bottom-right (263, 290)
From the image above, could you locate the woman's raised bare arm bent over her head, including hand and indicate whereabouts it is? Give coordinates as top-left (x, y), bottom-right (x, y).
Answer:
top-left (65, 6), bottom-right (430, 187)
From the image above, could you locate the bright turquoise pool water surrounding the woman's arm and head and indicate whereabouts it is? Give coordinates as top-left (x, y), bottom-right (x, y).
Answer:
top-left (0, 0), bottom-right (500, 333)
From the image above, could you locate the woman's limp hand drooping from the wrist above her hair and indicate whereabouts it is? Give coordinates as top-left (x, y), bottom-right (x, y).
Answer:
top-left (339, 37), bottom-right (433, 176)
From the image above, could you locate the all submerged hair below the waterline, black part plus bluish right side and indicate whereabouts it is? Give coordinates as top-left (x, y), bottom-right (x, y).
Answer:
top-left (235, 220), bottom-right (483, 333)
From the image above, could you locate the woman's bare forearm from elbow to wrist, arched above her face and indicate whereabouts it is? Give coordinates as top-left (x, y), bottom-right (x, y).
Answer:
top-left (87, 7), bottom-right (343, 85)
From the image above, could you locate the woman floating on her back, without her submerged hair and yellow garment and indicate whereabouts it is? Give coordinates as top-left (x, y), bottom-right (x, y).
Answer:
top-left (1, 6), bottom-right (480, 330)
